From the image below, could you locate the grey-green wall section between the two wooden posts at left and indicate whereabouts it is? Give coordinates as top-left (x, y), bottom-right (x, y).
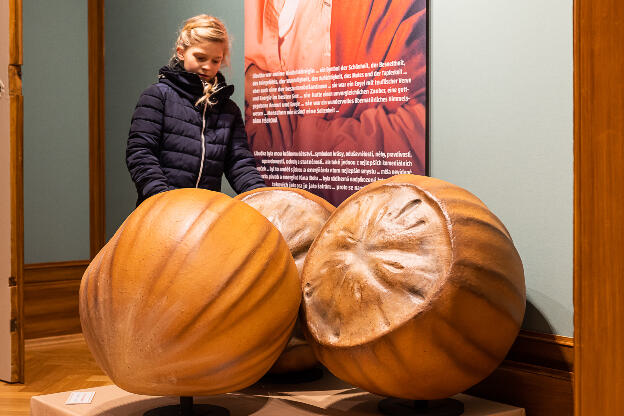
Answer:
top-left (22, 0), bottom-right (89, 264)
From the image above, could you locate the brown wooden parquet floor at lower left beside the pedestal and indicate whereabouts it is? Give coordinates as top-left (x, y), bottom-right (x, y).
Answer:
top-left (0, 334), bottom-right (112, 416)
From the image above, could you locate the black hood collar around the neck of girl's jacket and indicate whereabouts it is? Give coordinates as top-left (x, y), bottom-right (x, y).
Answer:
top-left (158, 63), bottom-right (234, 104)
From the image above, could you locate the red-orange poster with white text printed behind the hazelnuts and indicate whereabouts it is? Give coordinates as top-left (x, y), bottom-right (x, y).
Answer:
top-left (245, 0), bottom-right (428, 205)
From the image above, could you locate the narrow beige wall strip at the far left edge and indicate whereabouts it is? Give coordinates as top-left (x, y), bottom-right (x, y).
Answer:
top-left (0, 0), bottom-right (11, 380)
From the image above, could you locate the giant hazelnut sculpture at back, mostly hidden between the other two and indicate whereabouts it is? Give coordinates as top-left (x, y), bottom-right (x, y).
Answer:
top-left (235, 187), bottom-right (335, 374)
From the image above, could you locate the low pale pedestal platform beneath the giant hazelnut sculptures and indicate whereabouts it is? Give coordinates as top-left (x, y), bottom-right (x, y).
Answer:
top-left (30, 376), bottom-right (525, 416)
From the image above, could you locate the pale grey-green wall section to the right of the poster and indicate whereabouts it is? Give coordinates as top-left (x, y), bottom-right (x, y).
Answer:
top-left (430, 0), bottom-right (574, 337)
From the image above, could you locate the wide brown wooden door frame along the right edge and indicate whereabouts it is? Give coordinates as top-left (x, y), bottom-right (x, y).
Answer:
top-left (574, 0), bottom-right (624, 415)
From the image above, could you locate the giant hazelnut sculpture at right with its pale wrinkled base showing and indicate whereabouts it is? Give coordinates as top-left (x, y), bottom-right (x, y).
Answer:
top-left (302, 175), bottom-right (525, 400)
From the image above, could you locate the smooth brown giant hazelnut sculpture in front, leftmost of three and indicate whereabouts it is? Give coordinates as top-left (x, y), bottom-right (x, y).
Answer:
top-left (80, 189), bottom-right (301, 396)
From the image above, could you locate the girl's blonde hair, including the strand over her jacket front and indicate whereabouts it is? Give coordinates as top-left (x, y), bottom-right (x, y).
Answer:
top-left (169, 14), bottom-right (230, 106)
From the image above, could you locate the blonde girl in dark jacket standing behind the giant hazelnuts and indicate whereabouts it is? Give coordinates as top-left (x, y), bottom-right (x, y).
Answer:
top-left (126, 15), bottom-right (265, 206)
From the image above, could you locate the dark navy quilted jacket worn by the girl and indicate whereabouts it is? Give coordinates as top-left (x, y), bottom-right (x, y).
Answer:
top-left (126, 66), bottom-right (265, 205)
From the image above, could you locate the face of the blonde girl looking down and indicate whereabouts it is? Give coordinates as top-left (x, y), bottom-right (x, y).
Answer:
top-left (177, 41), bottom-right (224, 81)
